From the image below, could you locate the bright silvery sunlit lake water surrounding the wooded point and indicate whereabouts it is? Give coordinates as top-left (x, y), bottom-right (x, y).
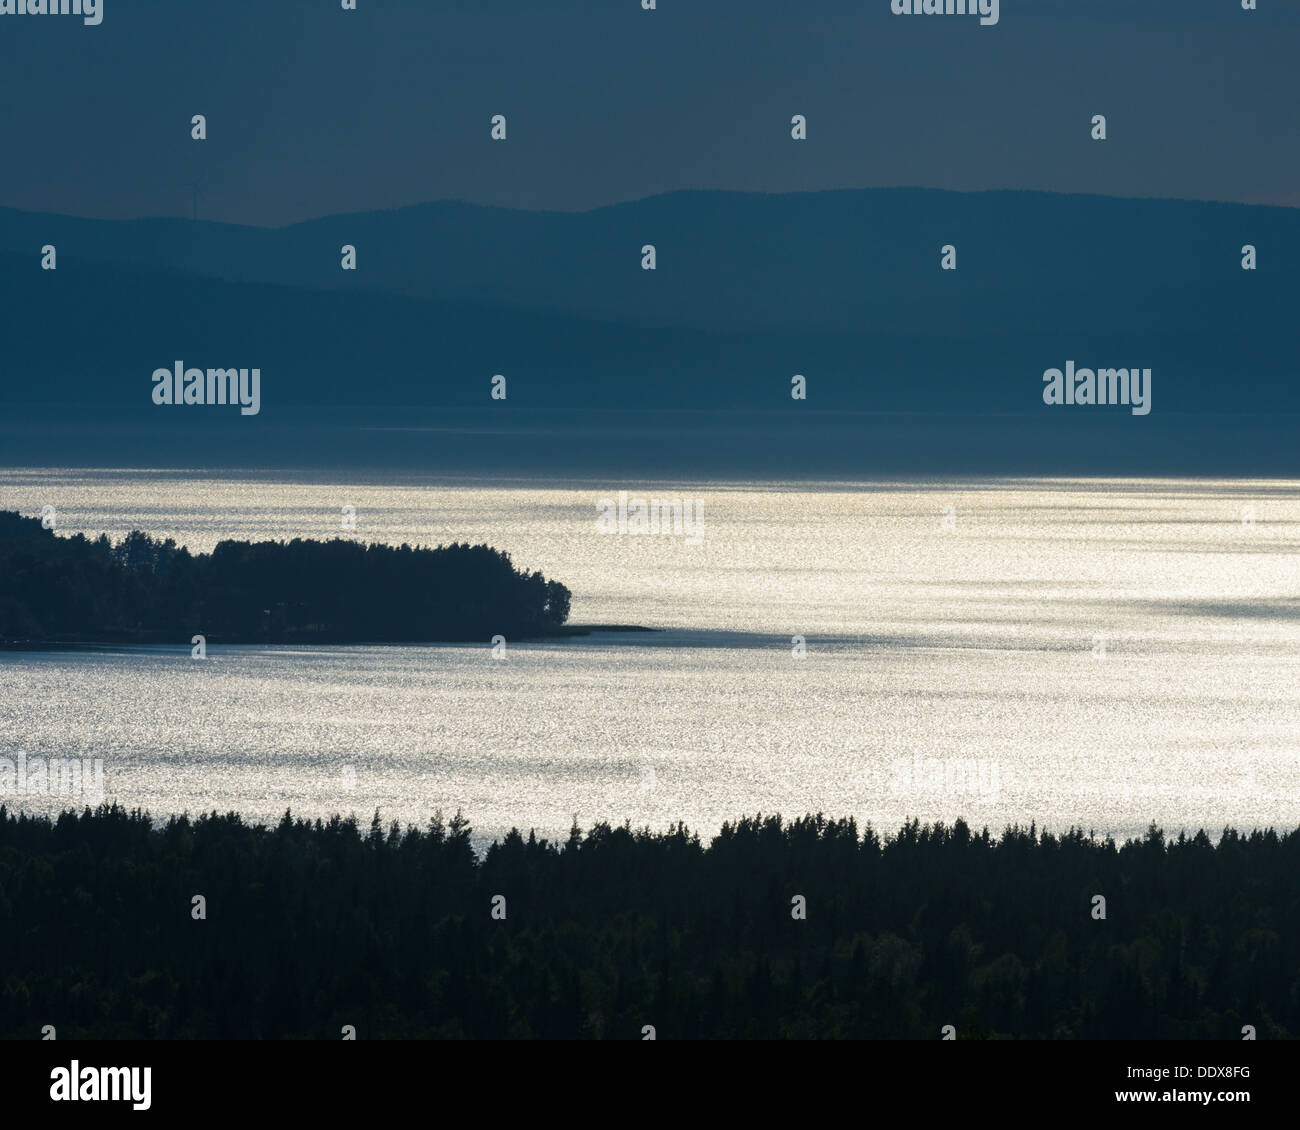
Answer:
top-left (0, 471), bottom-right (1300, 843)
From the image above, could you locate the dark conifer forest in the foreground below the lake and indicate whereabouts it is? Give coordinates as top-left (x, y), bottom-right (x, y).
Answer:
top-left (0, 808), bottom-right (1300, 1040)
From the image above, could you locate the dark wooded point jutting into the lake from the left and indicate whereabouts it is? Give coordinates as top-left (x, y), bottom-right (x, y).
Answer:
top-left (0, 511), bottom-right (569, 644)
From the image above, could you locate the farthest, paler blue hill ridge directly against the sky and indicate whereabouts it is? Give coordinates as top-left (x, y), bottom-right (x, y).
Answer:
top-left (0, 189), bottom-right (1300, 337)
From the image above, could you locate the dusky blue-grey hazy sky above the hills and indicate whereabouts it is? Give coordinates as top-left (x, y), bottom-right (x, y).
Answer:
top-left (0, 0), bottom-right (1300, 225)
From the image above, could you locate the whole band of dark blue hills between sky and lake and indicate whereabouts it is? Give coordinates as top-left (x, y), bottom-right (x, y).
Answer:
top-left (0, 190), bottom-right (1300, 469)
